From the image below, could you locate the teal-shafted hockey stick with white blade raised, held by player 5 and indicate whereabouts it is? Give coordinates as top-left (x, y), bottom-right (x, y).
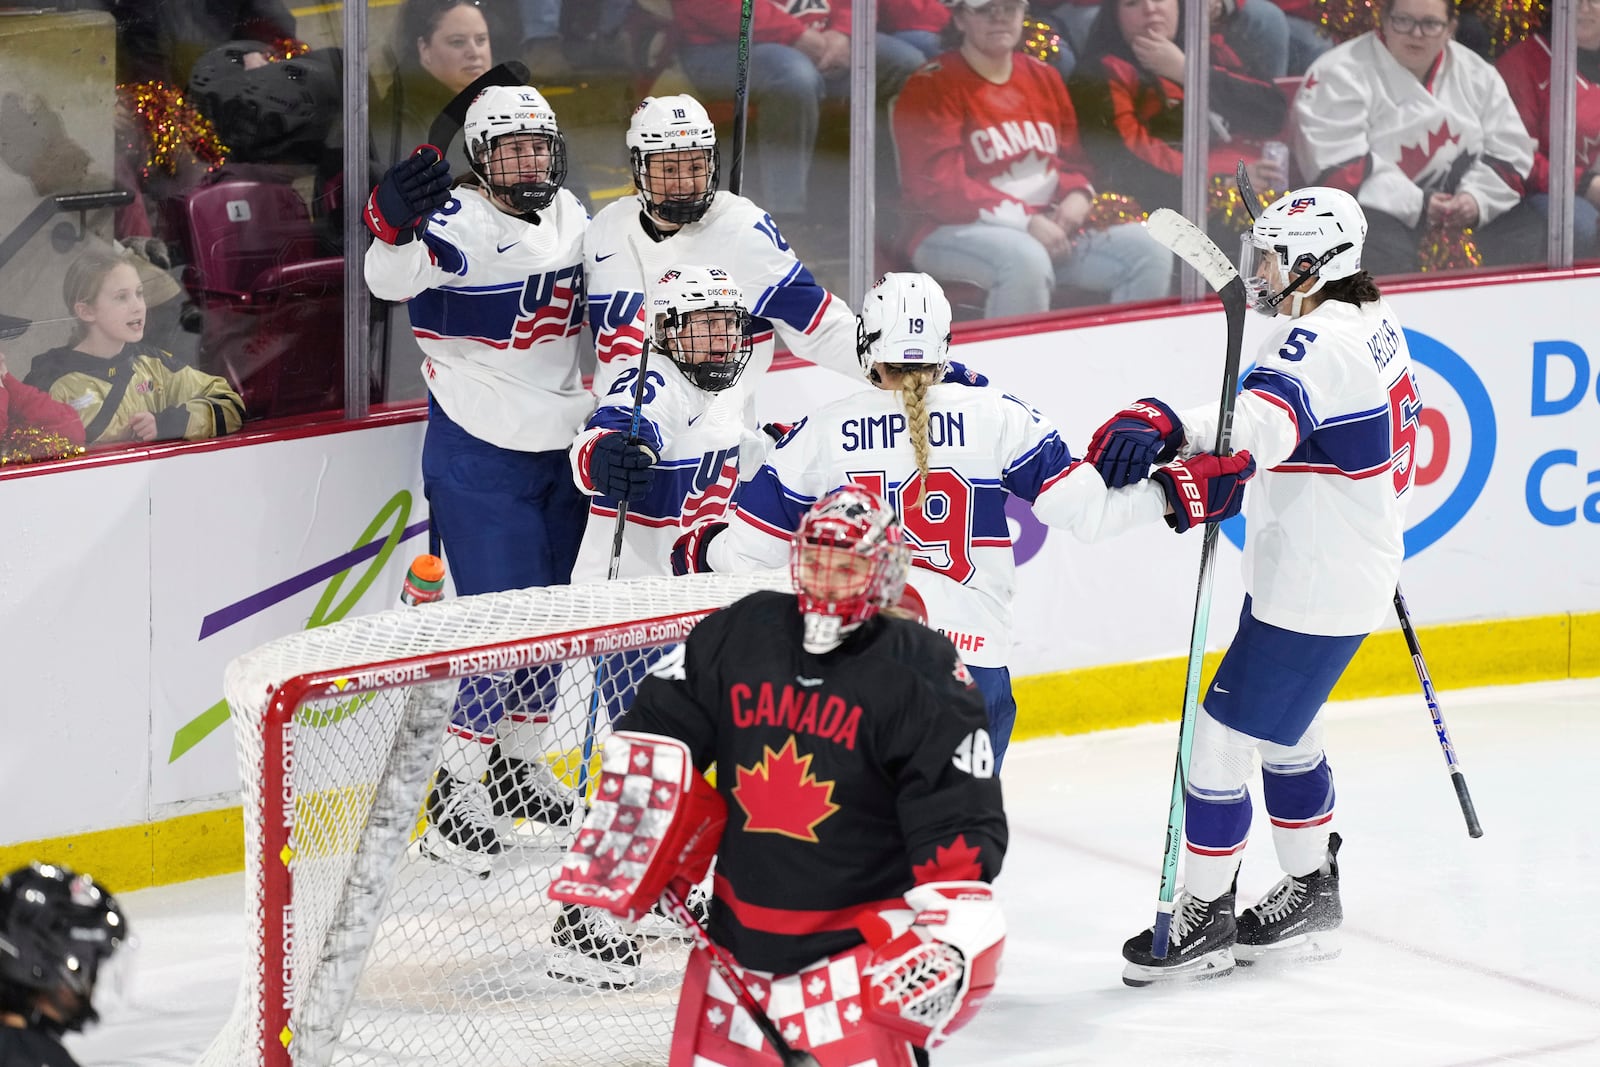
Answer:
top-left (1144, 208), bottom-right (1245, 960)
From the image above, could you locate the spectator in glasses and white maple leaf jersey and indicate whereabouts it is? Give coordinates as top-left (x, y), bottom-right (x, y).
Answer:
top-left (1294, 0), bottom-right (1544, 274)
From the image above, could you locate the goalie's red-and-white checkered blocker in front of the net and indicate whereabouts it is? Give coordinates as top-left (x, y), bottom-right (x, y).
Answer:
top-left (549, 729), bottom-right (728, 923)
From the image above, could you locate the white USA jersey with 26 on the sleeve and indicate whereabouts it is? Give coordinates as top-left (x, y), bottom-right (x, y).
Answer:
top-left (571, 352), bottom-right (765, 584)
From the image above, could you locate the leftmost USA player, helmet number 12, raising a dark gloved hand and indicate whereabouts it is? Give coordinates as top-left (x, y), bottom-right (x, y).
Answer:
top-left (365, 86), bottom-right (594, 870)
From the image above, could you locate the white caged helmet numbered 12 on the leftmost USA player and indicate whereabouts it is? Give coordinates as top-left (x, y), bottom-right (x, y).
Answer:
top-left (462, 85), bottom-right (566, 214)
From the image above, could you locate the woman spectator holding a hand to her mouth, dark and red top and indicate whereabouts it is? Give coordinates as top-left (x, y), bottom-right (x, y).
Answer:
top-left (1069, 0), bottom-right (1288, 223)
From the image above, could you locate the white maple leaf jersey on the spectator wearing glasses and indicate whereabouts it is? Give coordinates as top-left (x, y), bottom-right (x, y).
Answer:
top-left (1294, 30), bottom-right (1534, 226)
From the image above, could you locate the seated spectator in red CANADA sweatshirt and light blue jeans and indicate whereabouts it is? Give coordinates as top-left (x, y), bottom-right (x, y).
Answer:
top-left (894, 0), bottom-right (1173, 317)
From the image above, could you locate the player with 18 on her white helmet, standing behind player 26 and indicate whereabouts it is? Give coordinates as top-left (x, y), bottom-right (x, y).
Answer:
top-left (584, 96), bottom-right (854, 404)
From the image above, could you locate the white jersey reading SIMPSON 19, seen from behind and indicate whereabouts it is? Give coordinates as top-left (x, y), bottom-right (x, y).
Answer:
top-left (707, 382), bottom-right (1166, 667)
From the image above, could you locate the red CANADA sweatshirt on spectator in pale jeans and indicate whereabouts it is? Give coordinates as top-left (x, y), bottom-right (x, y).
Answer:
top-left (894, 51), bottom-right (1091, 259)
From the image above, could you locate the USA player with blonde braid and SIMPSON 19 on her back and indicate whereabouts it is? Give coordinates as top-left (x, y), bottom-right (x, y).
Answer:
top-left (674, 274), bottom-right (1254, 768)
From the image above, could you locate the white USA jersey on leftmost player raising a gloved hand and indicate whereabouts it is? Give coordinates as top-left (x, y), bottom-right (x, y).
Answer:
top-left (365, 186), bottom-right (594, 451)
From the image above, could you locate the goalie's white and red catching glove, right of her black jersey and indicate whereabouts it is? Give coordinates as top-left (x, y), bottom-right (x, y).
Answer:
top-left (856, 881), bottom-right (1005, 1048)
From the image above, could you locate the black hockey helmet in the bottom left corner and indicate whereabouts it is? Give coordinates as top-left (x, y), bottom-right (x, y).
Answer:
top-left (0, 864), bottom-right (128, 1030)
